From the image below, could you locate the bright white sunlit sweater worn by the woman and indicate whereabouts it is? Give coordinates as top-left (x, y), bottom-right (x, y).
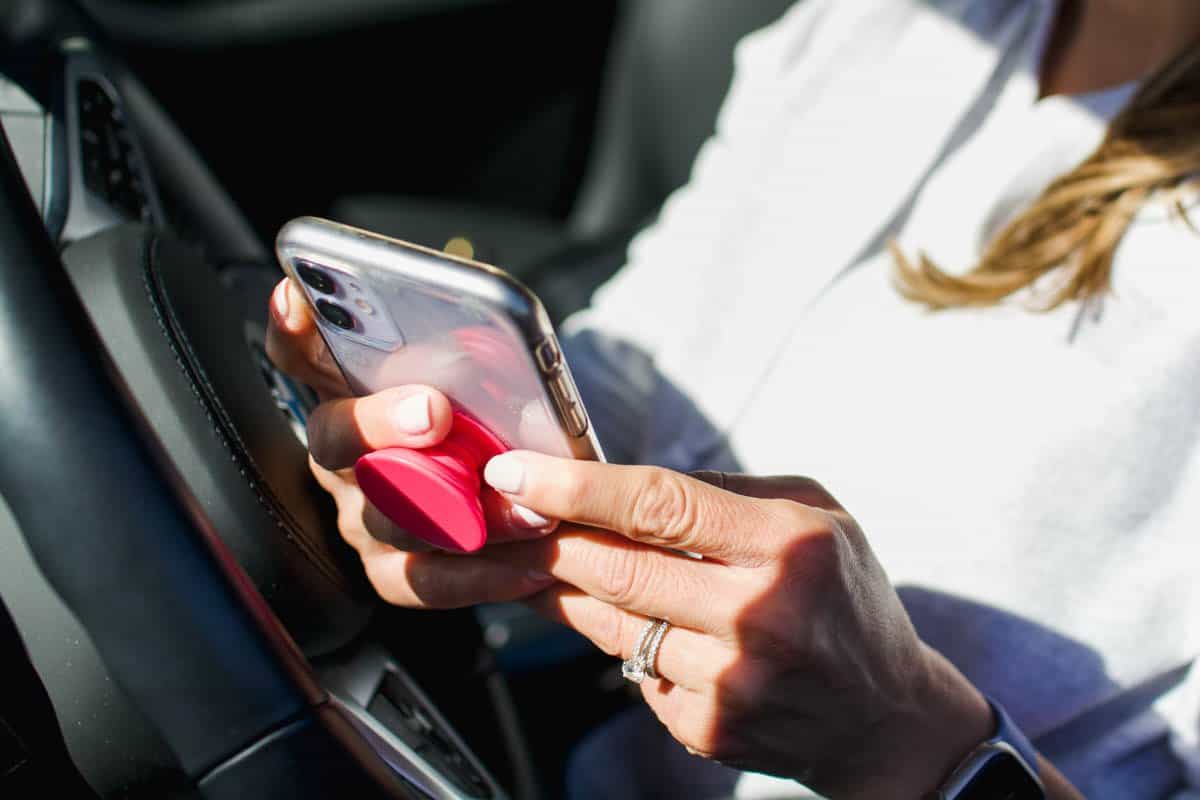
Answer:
top-left (566, 0), bottom-right (1200, 798)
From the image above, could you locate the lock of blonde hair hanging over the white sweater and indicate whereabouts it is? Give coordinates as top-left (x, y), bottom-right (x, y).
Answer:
top-left (889, 46), bottom-right (1200, 311)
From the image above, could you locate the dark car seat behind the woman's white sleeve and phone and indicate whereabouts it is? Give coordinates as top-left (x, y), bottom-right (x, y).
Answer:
top-left (331, 0), bottom-right (794, 320)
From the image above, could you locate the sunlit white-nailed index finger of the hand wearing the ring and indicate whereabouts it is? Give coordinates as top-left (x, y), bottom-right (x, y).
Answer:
top-left (484, 450), bottom-right (799, 565)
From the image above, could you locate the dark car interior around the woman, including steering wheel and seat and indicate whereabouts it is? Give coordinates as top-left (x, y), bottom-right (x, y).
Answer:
top-left (0, 0), bottom-right (791, 800)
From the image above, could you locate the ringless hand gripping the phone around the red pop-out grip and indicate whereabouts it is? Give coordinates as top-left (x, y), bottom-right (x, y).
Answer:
top-left (266, 278), bottom-right (554, 608)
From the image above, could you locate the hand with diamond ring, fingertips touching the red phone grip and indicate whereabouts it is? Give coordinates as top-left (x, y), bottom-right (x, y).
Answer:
top-left (485, 451), bottom-right (994, 798)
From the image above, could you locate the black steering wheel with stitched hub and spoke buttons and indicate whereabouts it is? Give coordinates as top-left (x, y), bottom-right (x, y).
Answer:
top-left (0, 0), bottom-right (532, 799)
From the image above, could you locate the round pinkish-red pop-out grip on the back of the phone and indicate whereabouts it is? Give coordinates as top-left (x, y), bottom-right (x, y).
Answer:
top-left (354, 411), bottom-right (508, 553)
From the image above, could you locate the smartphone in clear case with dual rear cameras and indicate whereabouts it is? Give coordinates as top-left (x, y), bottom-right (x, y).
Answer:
top-left (276, 217), bottom-right (604, 461)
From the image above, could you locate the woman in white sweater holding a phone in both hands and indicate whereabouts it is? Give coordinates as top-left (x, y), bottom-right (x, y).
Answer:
top-left (271, 0), bottom-right (1200, 798)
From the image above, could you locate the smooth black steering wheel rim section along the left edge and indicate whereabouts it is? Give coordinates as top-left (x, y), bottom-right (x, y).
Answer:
top-left (0, 118), bottom-right (318, 776)
